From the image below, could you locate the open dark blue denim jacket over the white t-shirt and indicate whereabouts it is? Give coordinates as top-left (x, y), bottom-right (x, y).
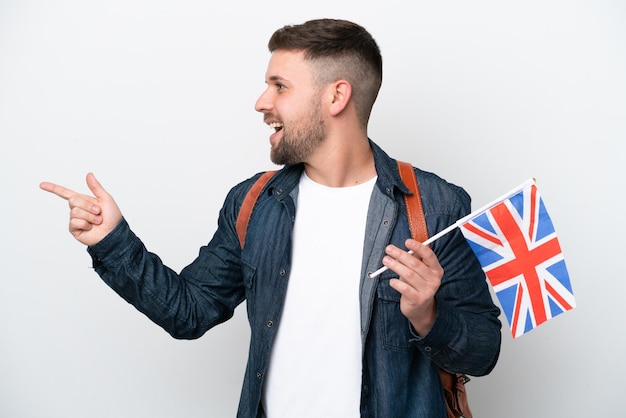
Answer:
top-left (88, 142), bottom-right (501, 418)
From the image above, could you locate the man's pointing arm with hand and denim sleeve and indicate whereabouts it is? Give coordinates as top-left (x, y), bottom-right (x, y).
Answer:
top-left (40, 174), bottom-right (244, 339)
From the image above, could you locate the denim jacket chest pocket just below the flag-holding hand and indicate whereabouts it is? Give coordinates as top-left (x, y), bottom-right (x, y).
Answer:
top-left (376, 280), bottom-right (413, 352)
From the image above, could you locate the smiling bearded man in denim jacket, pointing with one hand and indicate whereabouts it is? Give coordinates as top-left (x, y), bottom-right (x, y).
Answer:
top-left (41, 19), bottom-right (500, 418)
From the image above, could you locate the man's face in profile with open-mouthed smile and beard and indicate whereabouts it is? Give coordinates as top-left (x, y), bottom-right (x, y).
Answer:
top-left (255, 50), bottom-right (326, 164)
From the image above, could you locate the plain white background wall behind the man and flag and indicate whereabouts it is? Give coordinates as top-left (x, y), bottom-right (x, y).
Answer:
top-left (0, 0), bottom-right (626, 418)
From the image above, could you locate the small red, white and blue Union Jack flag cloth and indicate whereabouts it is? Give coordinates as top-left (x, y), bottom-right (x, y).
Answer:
top-left (461, 182), bottom-right (576, 338)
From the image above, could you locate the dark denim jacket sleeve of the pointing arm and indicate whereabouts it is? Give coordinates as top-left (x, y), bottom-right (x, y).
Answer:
top-left (87, 184), bottom-right (251, 339)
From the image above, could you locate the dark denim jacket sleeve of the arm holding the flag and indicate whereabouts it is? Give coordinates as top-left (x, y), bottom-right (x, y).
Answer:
top-left (413, 180), bottom-right (501, 376)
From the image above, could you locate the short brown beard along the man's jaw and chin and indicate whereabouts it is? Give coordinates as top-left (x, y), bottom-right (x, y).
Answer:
top-left (270, 98), bottom-right (326, 165)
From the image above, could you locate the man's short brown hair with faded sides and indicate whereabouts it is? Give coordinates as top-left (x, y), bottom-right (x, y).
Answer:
top-left (268, 19), bottom-right (383, 128)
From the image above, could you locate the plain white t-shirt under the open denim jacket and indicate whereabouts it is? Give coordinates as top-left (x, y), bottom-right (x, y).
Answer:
top-left (263, 173), bottom-right (376, 418)
